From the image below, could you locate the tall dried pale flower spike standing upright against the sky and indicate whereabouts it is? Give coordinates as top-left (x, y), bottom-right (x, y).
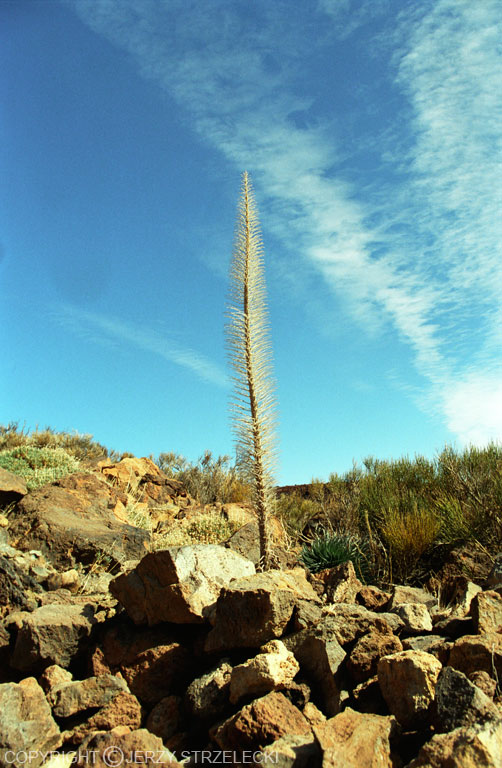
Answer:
top-left (226, 172), bottom-right (276, 570)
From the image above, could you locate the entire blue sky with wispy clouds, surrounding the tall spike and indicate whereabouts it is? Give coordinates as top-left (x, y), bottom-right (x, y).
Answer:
top-left (0, 0), bottom-right (502, 483)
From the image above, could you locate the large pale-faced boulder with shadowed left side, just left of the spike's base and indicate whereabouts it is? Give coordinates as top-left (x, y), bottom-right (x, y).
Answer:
top-left (110, 544), bottom-right (255, 626)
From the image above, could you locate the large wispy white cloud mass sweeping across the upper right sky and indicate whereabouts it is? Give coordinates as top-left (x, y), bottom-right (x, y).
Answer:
top-left (71, 0), bottom-right (502, 440)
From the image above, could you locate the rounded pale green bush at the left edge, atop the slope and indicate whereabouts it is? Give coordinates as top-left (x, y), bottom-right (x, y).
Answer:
top-left (0, 445), bottom-right (80, 490)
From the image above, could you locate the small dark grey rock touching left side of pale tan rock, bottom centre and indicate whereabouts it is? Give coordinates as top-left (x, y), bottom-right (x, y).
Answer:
top-left (184, 659), bottom-right (232, 720)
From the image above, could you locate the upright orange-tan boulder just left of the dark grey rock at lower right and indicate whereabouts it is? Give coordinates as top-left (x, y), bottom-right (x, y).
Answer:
top-left (378, 651), bottom-right (442, 730)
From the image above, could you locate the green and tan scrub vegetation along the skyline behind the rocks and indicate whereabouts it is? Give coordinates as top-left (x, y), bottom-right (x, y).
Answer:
top-left (0, 424), bottom-right (502, 583)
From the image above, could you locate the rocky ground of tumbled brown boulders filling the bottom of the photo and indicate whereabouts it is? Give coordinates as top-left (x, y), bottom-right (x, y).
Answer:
top-left (0, 459), bottom-right (502, 768)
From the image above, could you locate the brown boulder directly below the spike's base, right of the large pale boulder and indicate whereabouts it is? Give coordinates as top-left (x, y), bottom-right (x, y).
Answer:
top-left (205, 568), bottom-right (318, 653)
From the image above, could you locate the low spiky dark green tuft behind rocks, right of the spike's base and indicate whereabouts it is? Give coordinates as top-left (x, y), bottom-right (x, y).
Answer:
top-left (300, 534), bottom-right (371, 581)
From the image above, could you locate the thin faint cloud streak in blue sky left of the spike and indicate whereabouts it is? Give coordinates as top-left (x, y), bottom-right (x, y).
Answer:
top-left (53, 304), bottom-right (229, 388)
